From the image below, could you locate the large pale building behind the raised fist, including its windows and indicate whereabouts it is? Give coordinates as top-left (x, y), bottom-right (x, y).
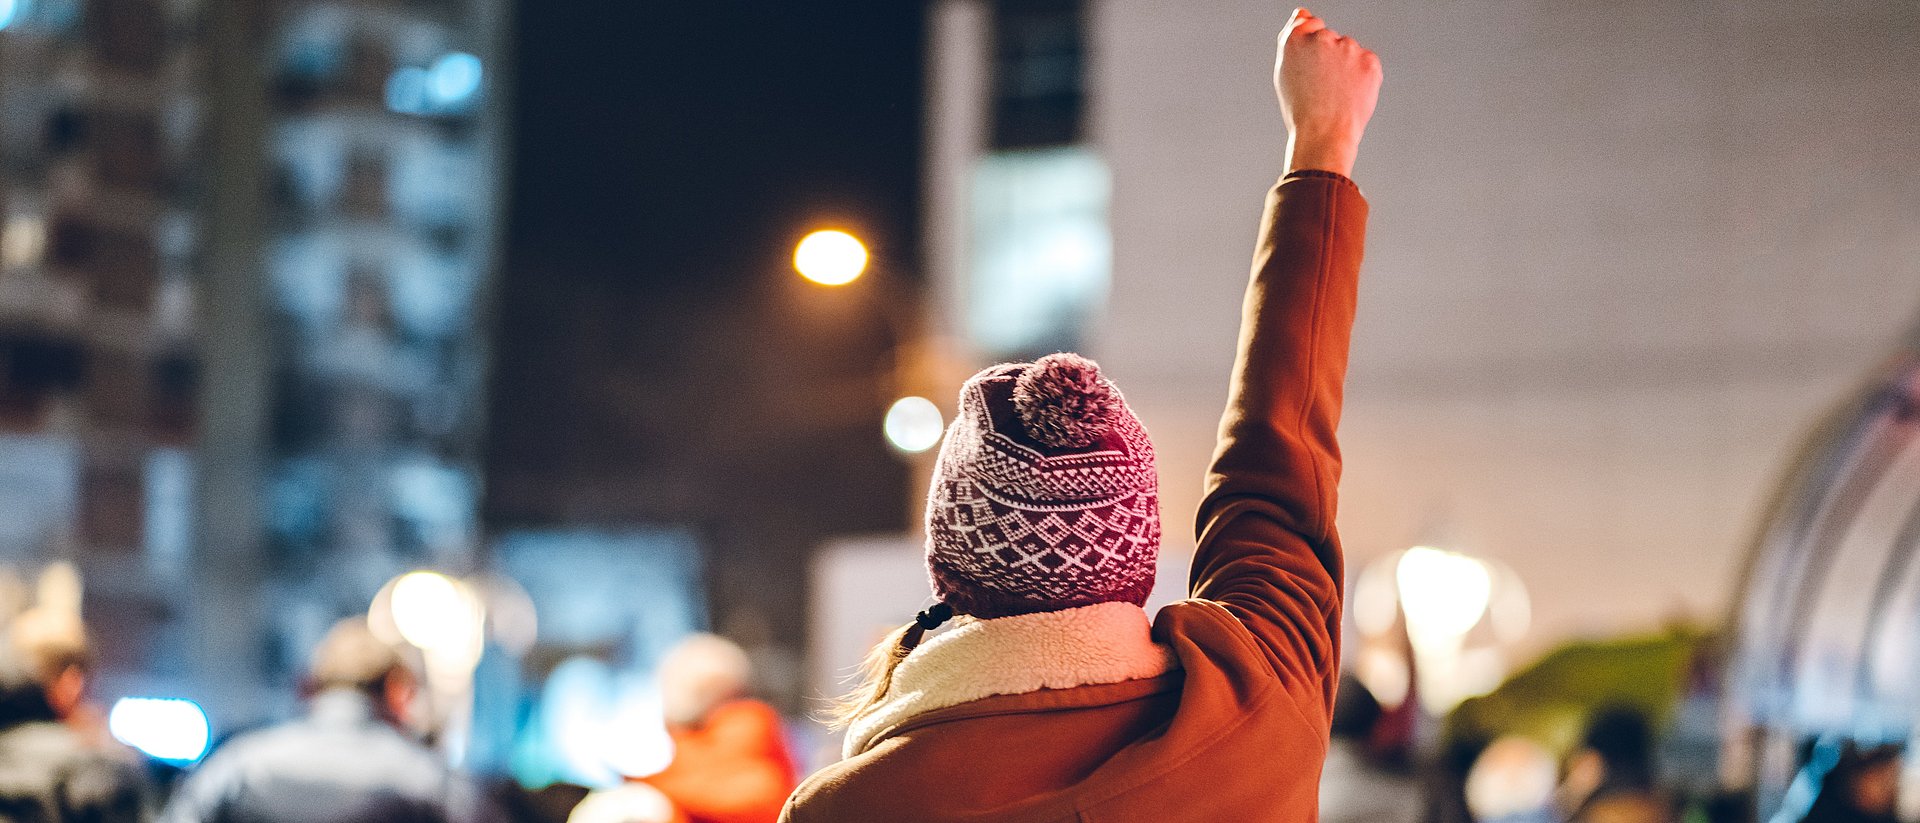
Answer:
top-left (925, 0), bottom-right (1920, 648)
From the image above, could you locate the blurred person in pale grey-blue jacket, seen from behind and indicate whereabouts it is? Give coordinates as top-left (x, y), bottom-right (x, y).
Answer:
top-left (163, 618), bottom-right (490, 823)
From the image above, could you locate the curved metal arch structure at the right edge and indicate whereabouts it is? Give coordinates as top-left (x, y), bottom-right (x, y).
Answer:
top-left (1722, 345), bottom-right (1920, 819)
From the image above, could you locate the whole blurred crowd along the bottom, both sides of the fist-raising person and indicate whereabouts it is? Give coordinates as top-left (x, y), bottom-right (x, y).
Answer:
top-left (0, 598), bottom-right (1903, 823)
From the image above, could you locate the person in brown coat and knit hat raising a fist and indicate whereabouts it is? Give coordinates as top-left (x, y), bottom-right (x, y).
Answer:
top-left (783, 10), bottom-right (1380, 823)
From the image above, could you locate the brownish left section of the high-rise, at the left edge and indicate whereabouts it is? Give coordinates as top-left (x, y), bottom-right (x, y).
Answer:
top-left (0, 0), bottom-right (205, 686)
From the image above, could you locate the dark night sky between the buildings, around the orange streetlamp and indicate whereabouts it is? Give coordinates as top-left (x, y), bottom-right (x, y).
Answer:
top-left (484, 0), bottom-right (924, 645)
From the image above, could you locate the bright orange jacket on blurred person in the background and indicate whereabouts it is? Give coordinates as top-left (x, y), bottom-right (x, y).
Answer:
top-left (641, 700), bottom-right (795, 823)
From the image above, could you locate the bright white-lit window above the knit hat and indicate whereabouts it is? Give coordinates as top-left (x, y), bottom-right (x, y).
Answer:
top-left (966, 146), bottom-right (1114, 359)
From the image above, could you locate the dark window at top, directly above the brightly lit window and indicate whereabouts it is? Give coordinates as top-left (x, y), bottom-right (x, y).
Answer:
top-left (993, 0), bottom-right (1087, 148)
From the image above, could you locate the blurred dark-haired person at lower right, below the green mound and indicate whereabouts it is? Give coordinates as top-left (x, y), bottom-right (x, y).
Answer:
top-left (1563, 706), bottom-right (1676, 823)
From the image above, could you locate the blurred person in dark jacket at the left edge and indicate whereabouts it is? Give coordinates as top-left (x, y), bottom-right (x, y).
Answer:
top-left (0, 612), bottom-right (146, 823)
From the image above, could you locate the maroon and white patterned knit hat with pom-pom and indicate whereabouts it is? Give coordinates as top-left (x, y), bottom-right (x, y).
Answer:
top-left (927, 355), bottom-right (1160, 618)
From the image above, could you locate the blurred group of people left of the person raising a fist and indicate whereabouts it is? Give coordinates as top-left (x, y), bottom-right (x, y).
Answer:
top-left (0, 594), bottom-right (797, 823)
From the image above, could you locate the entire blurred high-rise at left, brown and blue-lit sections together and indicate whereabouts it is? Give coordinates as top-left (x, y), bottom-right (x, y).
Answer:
top-left (0, 0), bottom-right (505, 731)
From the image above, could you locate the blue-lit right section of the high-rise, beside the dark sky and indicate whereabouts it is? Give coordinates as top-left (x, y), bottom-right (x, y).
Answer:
top-left (261, 0), bottom-right (505, 694)
